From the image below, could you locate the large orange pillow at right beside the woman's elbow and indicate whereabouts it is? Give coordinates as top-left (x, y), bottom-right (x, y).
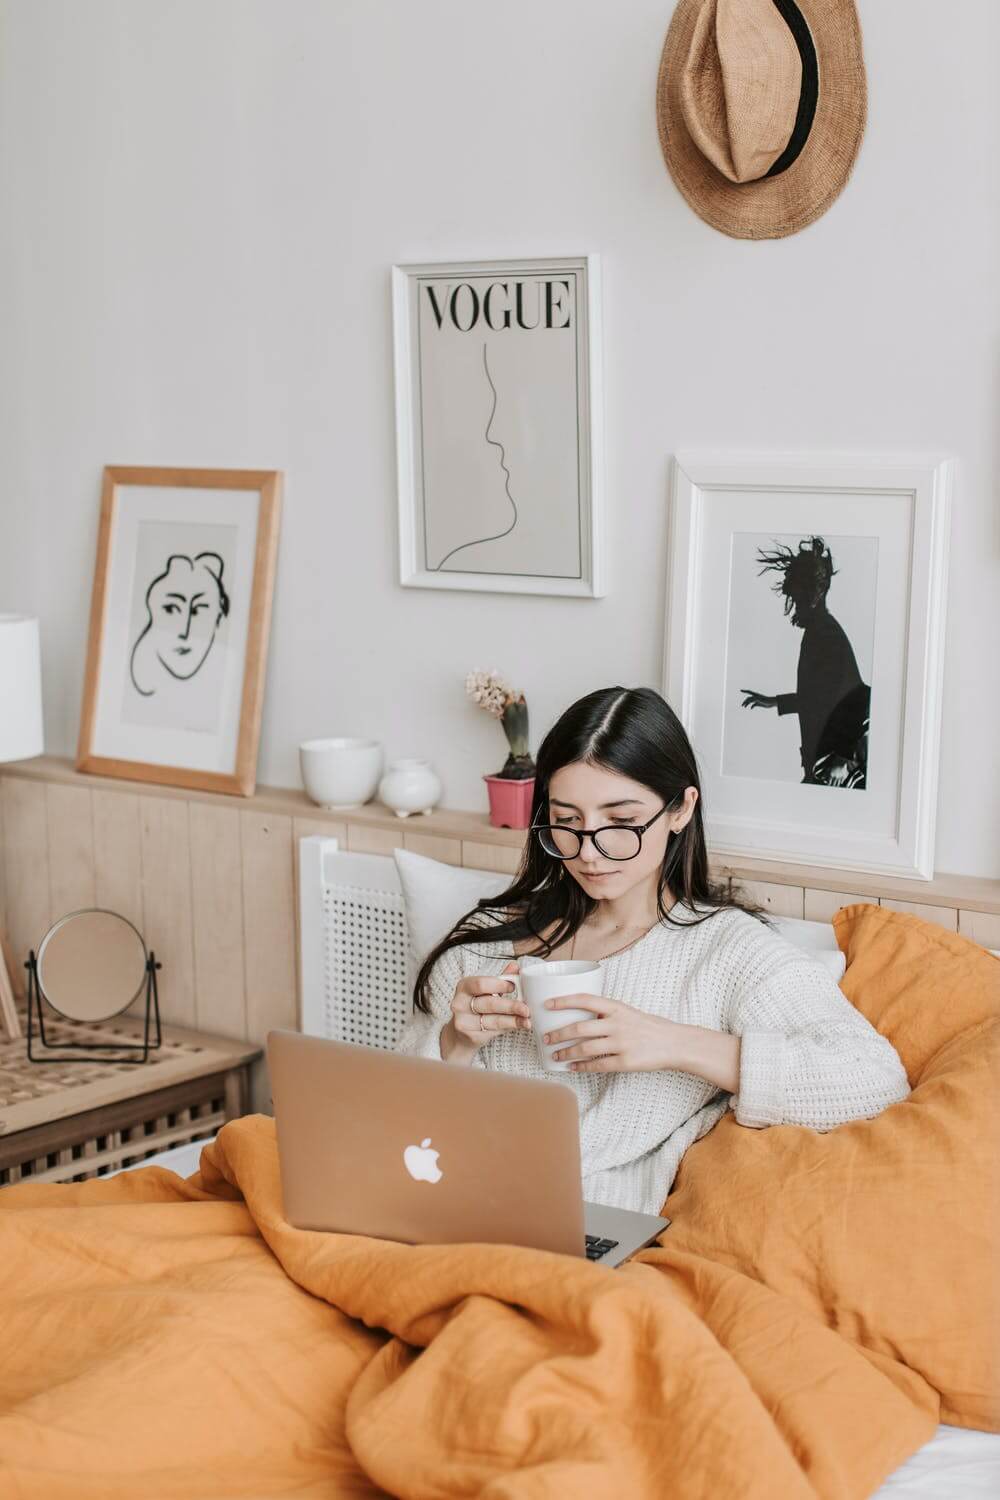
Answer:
top-left (664, 906), bottom-right (1000, 1433)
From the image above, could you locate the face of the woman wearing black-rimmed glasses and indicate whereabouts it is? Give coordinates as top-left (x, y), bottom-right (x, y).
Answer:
top-left (549, 761), bottom-right (697, 902)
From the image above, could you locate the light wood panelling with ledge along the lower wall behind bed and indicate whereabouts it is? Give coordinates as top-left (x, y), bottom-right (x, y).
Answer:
top-left (0, 767), bottom-right (1000, 1109)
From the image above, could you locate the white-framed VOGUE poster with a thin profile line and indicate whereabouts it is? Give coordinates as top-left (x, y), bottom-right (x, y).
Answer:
top-left (393, 255), bottom-right (604, 597)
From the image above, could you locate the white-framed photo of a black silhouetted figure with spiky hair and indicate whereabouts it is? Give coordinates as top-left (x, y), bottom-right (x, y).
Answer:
top-left (664, 453), bottom-right (951, 879)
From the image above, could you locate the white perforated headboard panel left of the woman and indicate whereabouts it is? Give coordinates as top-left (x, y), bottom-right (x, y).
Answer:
top-left (298, 836), bottom-right (411, 1049)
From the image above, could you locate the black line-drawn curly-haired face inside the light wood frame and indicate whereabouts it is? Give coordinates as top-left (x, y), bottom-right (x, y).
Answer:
top-left (129, 552), bottom-right (229, 698)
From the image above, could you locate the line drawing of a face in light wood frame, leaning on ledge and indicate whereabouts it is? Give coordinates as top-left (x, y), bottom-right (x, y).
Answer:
top-left (76, 468), bottom-right (282, 797)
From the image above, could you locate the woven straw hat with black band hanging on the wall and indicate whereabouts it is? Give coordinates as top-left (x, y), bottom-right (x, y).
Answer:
top-left (657, 0), bottom-right (867, 240)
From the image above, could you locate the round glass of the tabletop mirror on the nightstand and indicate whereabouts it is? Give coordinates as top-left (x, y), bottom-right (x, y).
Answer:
top-left (37, 909), bottom-right (147, 1022)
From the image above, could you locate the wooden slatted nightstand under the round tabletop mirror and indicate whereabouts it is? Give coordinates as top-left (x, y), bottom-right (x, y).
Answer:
top-left (0, 1011), bottom-right (262, 1187)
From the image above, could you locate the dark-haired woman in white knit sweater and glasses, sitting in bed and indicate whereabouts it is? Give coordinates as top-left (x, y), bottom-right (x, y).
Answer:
top-left (397, 687), bottom-right (910, 1214)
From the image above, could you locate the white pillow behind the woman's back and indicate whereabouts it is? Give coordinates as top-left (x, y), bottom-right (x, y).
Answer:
top-left (393, 849), bottom-right (847, 981)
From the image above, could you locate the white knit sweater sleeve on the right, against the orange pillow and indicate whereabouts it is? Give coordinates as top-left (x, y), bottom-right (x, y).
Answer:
top-left (729, 935), bottom-right (910, 1131)
